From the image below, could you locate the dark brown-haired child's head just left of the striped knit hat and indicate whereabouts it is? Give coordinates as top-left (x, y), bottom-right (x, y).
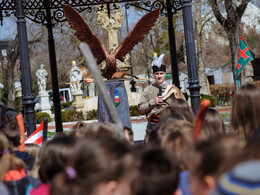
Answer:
top-left (190, 135), bottom-right (244, 195)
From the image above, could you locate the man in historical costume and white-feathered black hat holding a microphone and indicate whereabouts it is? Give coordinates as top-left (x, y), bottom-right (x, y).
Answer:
top-left (138, 54), bottom-right (185, 142)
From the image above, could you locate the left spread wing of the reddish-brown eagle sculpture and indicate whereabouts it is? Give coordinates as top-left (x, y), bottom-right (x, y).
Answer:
top-left (63, 4), bottom-right (109, 64)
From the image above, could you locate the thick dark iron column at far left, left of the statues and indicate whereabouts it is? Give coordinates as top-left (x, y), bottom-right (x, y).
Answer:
top-left (16, 0), bottom-right (36, 135)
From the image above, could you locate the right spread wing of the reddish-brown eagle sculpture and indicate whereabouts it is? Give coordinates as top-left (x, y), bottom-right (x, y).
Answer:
top-left (114, 9), bottom-right (160, 62)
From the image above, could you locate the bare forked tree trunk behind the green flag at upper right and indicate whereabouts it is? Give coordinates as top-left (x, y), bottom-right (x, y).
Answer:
top-left (209, 0), bottom-right (251, 87)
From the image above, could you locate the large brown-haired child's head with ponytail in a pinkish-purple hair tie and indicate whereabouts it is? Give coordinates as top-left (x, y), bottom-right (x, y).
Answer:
top-left (51, 137), bottom-right (138, 195)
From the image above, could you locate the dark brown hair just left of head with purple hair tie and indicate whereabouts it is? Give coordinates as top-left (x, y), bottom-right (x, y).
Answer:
top-left (39, 137), bottom-right (75, 183)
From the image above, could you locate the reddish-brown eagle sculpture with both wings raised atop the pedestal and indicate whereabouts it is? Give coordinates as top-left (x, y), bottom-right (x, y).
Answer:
top-left (63, 4), bottom-right (160, 79)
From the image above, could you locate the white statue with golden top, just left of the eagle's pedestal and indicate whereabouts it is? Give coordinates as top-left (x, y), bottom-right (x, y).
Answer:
top-left (70, 61), bottom-right (82, 93)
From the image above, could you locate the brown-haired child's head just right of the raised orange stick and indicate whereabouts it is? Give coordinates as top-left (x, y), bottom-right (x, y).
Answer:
top-left (201, 108), bottom-right (225, 139)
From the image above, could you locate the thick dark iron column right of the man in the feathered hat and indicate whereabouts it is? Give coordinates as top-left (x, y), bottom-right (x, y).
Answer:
top-left (182, 0), bottom-right (201, 113)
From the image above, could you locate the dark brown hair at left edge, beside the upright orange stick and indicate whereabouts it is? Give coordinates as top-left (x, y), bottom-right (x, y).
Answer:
top-left (1, 117), bottom-right (21, 147)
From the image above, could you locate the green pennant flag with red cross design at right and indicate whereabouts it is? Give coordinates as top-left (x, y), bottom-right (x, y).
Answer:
top-left (235, 37), bottom-right (255, 89)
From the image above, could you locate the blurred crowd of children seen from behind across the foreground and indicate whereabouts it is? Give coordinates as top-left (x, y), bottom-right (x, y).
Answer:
top-left (0, 85), bottom-right (260, 195)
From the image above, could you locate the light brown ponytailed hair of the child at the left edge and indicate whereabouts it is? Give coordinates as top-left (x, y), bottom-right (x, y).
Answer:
top-left (0, 132), bottom-right (25, 182)
